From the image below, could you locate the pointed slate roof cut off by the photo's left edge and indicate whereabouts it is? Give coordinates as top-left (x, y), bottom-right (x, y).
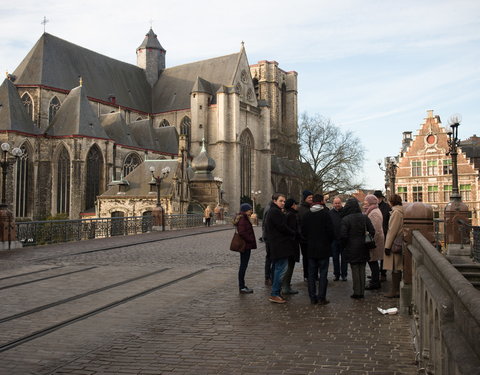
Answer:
top-left (0, 79), bottom-right (40, 134)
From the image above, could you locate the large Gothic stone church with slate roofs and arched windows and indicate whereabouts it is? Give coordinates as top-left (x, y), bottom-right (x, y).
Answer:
top-left (0, 29), bottom-right (300, 219)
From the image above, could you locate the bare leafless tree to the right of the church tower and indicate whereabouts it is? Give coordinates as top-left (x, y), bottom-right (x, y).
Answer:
top-left (298, 113), bottom-right (365, 194)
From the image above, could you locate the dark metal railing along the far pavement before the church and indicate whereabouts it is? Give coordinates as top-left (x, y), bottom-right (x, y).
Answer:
top-left (16, 214), bottom-right (215, 246)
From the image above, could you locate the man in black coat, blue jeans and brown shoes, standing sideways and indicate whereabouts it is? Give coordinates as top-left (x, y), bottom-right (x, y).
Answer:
top-left (265, 193), bottom-right (296, 303)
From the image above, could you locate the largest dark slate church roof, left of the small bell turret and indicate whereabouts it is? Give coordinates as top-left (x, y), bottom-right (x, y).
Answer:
top-left (13, 33), bottom-right (151, 112)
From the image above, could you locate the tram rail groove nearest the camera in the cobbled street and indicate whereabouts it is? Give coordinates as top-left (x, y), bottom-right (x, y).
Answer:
top-left (0, 268), bottom-right (207, 353)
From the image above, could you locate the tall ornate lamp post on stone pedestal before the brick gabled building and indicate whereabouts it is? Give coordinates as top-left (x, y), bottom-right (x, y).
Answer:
top-left (445, 115), bottom-right (469, 247)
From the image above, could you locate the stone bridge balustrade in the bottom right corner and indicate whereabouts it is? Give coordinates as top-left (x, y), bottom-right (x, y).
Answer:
top-left (408, 231), bottom-right (480, 375)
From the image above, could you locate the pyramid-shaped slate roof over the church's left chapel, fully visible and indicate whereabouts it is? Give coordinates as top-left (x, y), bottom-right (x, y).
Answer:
top-left (45, 86), bottom-right (110, 139)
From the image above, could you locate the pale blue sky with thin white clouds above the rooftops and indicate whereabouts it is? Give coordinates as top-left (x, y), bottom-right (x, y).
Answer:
top-left (0, 0), bottom-right (480, 189)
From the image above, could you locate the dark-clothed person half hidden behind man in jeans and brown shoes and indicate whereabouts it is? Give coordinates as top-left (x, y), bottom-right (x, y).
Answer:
top-left (282, 198), bottom-right (300, 295)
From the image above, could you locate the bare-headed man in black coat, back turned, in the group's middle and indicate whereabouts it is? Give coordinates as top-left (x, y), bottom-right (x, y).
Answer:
top-left (302, 194), bottom-right (335, 305)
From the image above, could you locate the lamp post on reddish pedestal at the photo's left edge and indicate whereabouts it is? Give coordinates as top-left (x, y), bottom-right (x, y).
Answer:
top-left (0, 142), bottom-right (22, 249)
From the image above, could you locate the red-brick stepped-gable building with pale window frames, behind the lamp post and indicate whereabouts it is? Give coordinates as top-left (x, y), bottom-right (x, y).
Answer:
top-left (396, 110), bottom-right (480, 225)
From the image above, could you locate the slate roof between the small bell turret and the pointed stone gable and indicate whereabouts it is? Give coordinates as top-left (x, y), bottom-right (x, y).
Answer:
top-left (152, 52), bottom-right (241, 113)
